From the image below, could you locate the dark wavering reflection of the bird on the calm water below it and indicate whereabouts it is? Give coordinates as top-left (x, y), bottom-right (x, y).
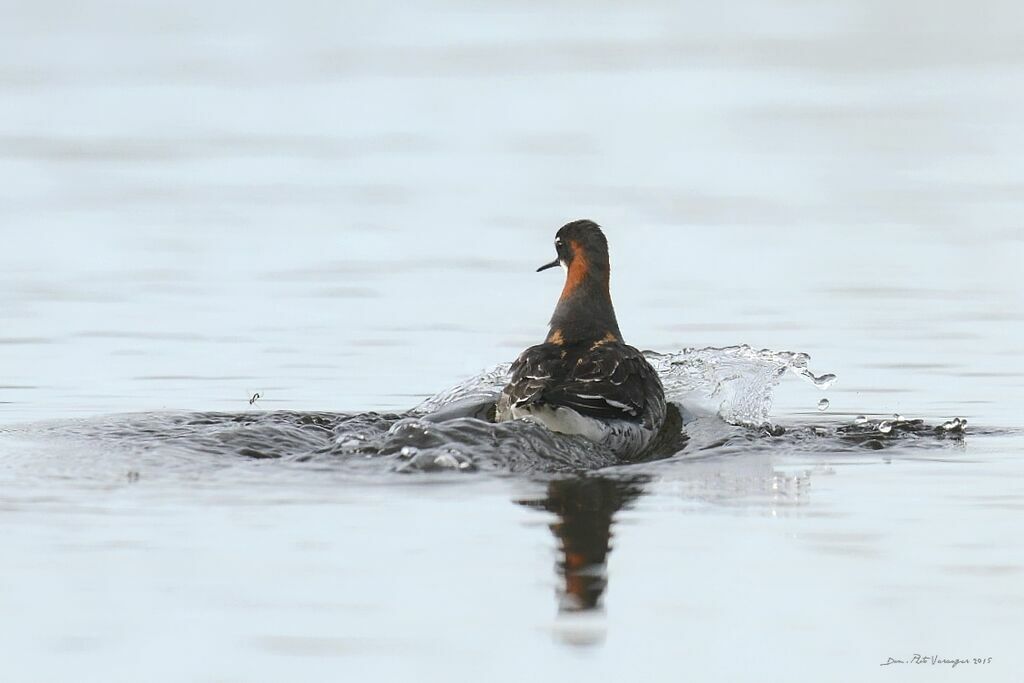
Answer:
top-left (519, 476), bottom-right (647, 614)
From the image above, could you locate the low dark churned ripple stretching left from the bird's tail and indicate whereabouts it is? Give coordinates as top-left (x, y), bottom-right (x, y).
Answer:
top-left (29, 411), bottom-right (621, 476)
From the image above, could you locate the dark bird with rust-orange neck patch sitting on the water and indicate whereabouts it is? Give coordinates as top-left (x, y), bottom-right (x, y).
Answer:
top-left (495, 219), bottom-right (667, 460)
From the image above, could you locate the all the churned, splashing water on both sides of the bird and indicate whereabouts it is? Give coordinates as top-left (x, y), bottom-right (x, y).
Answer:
top-left (6, 346), bottom-right (983, 474)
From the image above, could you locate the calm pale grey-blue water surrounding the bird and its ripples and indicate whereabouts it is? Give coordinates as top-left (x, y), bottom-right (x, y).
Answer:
top-left (0, 0), bottom-right (1024, 681)
